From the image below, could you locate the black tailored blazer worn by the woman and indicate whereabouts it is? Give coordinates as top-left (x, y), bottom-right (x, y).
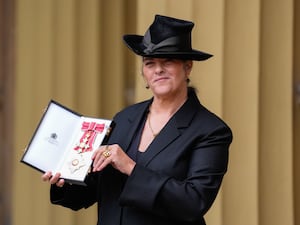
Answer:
top-left (50, 91), bottom-right (232, 225)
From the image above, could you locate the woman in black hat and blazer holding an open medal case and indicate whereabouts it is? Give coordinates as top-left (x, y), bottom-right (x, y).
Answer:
top-left (42, 15), bottom-right (232, 225)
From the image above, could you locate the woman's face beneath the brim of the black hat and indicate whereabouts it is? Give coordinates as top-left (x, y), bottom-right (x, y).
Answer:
top-left (142, 57), bottom-right (192, 96)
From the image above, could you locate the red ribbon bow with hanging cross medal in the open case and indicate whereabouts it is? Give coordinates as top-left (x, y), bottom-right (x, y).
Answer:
top-left (74, 122), bottom-right (105, 152)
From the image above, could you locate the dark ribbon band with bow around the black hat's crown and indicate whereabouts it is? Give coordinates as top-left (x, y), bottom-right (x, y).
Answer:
top-left (143, 30), bottom-right (192, 54)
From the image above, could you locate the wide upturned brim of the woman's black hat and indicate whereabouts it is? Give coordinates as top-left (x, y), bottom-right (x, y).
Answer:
top-left (123, 34), bottom-right (213, 61)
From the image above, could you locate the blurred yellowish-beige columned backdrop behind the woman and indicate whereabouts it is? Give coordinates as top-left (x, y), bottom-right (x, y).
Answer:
top-left (0, 0), bottom-right (300, 225)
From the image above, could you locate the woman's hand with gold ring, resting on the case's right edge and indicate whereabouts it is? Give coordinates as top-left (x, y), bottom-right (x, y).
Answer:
top-left (92, 144), bottom-right (136, 175)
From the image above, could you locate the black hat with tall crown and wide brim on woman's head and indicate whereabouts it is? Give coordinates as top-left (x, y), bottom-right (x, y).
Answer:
top-left (123, 15), bottom-right (212, 61)
